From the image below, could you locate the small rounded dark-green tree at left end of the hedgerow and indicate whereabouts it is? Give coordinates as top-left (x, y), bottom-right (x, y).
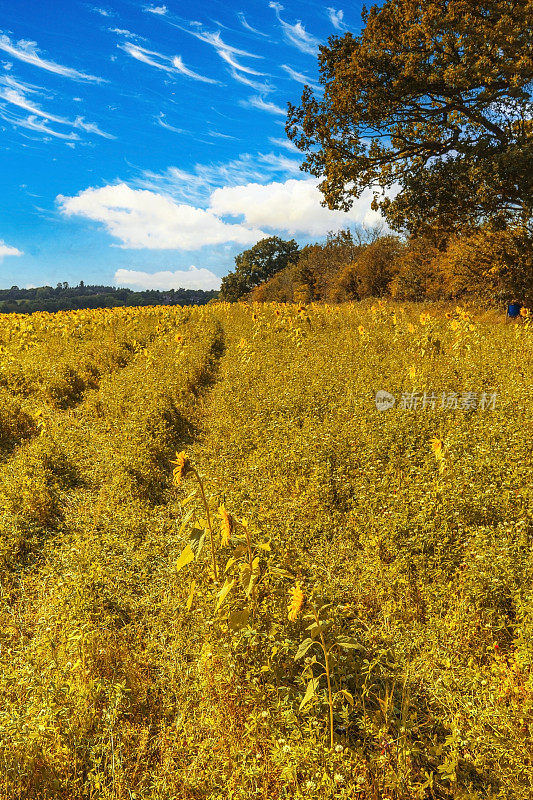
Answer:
top-left (220, 236), bottom-right (298, 302)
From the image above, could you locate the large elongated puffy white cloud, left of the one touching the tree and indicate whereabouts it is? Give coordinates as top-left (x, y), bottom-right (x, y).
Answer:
top-left (57, 183), bottom-right (264, 250)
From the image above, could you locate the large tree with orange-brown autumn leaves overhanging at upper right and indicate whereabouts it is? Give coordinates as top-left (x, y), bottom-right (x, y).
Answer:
top-left (287, 0), bottom-right (533, 238)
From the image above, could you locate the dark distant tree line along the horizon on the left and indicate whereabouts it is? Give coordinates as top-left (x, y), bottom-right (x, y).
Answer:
top-left (0, 281), bottom-right (218, 314)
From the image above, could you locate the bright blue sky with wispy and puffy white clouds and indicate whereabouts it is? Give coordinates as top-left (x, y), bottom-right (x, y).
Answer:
top-left (0, 0), bottom-right (382, 288)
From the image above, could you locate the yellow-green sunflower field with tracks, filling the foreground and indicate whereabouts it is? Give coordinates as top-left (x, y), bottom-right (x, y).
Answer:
top-left (0, 300), bottom-right (533, 800)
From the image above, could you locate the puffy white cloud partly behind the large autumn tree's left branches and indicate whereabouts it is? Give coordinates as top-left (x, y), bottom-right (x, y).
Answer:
top-left (210, 178), bottom-right (383, 236)
